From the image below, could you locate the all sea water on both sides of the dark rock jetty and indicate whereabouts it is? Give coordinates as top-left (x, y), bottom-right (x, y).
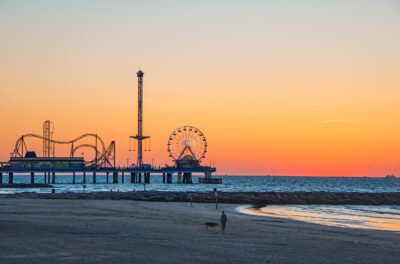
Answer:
top-left (0, 174), bottom-right (400, 231)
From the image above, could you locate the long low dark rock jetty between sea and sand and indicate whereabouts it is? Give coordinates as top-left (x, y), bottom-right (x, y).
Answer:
top-left (0, 191), bottom-right (400, 207)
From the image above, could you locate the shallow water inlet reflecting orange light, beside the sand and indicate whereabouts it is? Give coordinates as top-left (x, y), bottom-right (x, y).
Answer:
top-left (238, 205), bottom-right (400, 232)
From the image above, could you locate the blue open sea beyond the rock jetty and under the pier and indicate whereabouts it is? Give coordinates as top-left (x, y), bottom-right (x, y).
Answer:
top-left (0, 174), bottom-right (400, 193)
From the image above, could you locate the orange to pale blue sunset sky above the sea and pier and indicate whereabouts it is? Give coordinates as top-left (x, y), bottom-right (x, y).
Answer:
top-left (0, 0), bottom-right (400, 176)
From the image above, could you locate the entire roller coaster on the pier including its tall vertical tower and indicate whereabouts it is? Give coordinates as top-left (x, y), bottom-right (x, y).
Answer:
top-left (12, 121), bottom-right (115, 168)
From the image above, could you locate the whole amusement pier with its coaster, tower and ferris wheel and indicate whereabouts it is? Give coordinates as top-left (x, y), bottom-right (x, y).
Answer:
top-left (0, 70), bottom-right (222, 185)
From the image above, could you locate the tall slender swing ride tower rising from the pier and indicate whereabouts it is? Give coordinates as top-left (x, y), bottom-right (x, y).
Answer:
top-left (131, 70), bottom-right (150, 167)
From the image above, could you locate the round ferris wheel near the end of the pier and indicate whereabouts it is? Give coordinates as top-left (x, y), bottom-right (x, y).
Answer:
top-left (168, 126), bottom-right (207, 162)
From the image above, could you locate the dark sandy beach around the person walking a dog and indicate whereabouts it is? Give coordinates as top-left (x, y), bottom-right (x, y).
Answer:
top-left (0, 198), bottom-right (400, 264)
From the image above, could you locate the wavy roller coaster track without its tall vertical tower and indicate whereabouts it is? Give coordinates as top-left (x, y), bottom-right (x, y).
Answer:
top-left (12, 133), bottom-right (115, 167)
